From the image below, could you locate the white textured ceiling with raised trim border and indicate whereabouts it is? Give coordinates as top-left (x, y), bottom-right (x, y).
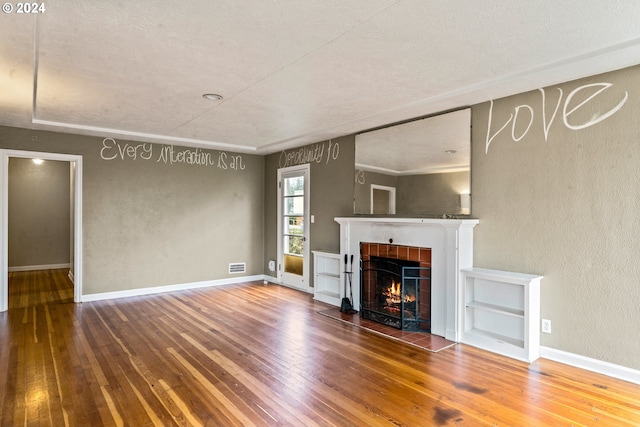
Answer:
top-left (0, 0), bottom-right (640, 154)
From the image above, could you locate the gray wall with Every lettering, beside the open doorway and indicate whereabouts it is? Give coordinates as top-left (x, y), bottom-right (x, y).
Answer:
top-left (0, 127), bottom-right (264, 294)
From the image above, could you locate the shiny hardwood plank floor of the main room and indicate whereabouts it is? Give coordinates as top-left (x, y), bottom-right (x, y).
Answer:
top-left (0, 274), bottom-right (640, 426)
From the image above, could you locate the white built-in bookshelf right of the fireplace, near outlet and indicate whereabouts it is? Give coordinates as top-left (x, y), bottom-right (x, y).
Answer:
top-left (461, 267), bottom-right (542, 363)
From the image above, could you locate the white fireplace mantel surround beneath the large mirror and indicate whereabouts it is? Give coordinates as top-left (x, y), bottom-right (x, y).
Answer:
top-left (335, 217), bottom-right (479, 342)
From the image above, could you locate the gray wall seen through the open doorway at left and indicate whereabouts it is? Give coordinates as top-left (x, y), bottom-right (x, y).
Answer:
top-left (8, 158), bottom-right (71, 267)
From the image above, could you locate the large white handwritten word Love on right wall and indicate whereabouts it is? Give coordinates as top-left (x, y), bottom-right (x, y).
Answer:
top-left (485, 82), bottom-right (629, 154)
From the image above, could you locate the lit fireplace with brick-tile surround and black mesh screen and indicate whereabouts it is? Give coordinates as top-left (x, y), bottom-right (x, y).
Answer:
top-left (360, 243), bottom-right (431, 331)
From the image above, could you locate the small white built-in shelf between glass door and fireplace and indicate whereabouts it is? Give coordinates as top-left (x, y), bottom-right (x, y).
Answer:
top-left (313, 251), bottom-right (342, 307)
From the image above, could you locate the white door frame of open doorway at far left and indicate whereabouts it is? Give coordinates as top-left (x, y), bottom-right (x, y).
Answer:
top-left (0, 149), bottom-right (82, 312)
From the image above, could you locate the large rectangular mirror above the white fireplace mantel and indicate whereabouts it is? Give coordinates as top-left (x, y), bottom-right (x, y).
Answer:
top-left (354, 108), bottom-right (471, 217)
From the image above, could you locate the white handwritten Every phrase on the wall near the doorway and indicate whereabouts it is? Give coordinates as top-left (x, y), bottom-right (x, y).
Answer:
top-left (100, 138), bottom-right (247, 170)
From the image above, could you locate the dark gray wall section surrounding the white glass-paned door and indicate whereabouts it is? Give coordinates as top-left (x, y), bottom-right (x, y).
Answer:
top-left (264, 136), bottom-right (355, 283)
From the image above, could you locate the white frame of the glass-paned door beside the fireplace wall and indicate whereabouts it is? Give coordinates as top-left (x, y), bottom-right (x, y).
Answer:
top-left (277, 163), bottom-right (313, 293)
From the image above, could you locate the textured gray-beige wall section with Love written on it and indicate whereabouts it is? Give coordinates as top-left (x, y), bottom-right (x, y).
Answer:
top-left (471, 67), bottom-right (640, 369)
